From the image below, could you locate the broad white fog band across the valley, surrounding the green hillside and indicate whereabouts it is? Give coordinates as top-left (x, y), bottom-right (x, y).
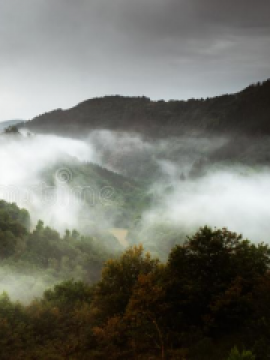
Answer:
top-left (0, 130), bottom-right (270, 241)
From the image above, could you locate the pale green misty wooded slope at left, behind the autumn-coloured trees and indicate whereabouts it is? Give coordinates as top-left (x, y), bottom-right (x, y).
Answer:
top-left (0, 201), bottom-right (116, 301)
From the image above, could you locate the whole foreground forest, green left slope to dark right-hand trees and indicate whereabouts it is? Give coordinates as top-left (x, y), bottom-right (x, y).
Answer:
top-left (0, 201), bottom-right (270, 360)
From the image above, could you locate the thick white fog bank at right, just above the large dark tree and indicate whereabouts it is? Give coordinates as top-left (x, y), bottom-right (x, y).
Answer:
top-left (141, 167), bottom-right (270, 248)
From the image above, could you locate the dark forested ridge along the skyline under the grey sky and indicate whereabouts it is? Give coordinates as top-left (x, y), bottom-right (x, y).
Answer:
top-left (27, 79), bottom-right (270, 136)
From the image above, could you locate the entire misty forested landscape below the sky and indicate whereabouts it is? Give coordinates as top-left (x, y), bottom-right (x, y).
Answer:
top-left (0, 81), bottom-right (270, 360)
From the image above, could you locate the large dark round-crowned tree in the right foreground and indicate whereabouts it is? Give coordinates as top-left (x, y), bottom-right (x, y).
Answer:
top-left (167, 227), bottom-right (269, 334)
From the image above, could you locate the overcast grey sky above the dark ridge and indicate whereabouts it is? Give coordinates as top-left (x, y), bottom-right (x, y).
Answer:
top-left (0, 0), bottom-right (270, 121)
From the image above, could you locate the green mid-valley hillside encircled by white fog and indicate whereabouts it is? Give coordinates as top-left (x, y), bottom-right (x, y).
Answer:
top-left (42, 158), bottom-right (151, 228)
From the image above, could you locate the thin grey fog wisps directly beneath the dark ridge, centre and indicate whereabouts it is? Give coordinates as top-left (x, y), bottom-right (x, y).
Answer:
top-left (87, 130), bottom-right (228, 180)
